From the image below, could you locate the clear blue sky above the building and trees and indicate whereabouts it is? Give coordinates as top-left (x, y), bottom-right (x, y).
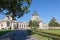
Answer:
top-left (0, 0), bottom-right (60, 23)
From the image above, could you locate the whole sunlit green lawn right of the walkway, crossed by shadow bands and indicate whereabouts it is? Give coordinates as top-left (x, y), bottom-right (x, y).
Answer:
top-left (29, 29), bottom-right (60, 40)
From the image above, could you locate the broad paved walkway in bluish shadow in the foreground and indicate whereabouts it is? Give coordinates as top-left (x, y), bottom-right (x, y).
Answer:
top-left (0, 30), bottom-right (40, 40)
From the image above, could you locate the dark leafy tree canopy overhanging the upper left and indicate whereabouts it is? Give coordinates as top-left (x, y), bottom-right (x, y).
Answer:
top-left (0, 0), bottom-right (32, 18)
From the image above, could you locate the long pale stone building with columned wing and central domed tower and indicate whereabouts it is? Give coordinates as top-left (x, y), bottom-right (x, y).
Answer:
top-left (0, 11), bottom-right (47, 30)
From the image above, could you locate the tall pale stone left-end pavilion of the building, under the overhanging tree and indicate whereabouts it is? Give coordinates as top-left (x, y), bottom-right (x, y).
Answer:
top-left (0, 15), bottom-right (17, 30)
